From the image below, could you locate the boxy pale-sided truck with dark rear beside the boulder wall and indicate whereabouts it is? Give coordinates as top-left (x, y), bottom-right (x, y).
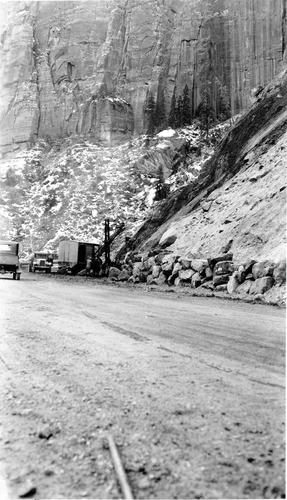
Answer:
top-left (58, 240), bottom-right (99, 274)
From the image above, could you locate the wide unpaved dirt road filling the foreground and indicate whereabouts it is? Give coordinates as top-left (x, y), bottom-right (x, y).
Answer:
top-left (0, 274), bottom-right (285, 499)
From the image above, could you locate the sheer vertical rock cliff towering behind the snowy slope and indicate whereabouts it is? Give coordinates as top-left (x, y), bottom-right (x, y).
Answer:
top-left (1, 0), bottom-right (286, 154)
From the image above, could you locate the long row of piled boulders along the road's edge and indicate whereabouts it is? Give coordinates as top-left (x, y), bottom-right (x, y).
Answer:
top-left (109, 250), bottom-right (286, 304)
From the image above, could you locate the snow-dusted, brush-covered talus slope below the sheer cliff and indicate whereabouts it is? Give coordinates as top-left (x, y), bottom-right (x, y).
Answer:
top-left (1, 123), bottom-right (225, 252)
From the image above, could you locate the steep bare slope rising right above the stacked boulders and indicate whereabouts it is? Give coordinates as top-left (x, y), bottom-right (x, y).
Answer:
top-left (125, 70), bottom-right (287, 260)
